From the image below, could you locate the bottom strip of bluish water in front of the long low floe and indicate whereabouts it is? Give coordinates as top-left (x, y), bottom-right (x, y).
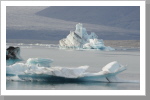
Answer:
top-left (6, 81), bottom-right (140, 90)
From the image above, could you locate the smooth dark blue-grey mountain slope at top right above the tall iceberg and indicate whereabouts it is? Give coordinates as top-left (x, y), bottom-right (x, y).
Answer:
top-left (36, 6), bottom-right (140, 30)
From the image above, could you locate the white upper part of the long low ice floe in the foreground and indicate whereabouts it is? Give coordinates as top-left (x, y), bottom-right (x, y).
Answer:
top-left (6, 58), bottom-right (125, 82)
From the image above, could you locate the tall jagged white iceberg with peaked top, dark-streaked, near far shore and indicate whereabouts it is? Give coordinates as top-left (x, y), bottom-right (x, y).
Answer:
top-left (59, 23), bottom-right (115, 50)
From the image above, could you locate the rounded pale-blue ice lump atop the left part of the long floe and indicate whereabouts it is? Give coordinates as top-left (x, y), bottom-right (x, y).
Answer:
top-left (26, 58), bottom-right (53, 67)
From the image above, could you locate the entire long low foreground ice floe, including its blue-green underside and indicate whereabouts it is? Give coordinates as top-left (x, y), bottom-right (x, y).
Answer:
top-left (6, 58), bottom-right (135, 82)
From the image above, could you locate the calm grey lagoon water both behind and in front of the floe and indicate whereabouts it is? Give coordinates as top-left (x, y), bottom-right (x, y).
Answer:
top-left (6, 44), bottom-right (140, 90)
